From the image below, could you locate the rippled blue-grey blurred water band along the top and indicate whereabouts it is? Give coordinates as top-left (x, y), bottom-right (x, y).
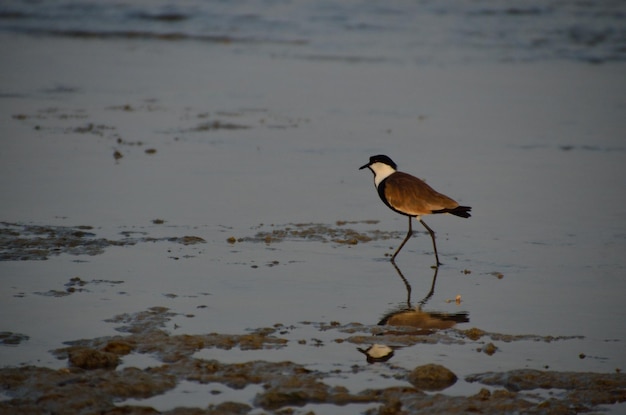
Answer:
top-left (0, 0), bottom-right (626, 64)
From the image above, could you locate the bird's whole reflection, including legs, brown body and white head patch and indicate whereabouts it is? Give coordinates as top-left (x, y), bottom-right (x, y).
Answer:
top-left (357, 262), bottom-right (469, 363)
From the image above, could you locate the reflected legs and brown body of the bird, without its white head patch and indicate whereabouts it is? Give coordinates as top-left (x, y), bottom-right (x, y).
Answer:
top-left (378, 262), bottom-right (469, 335)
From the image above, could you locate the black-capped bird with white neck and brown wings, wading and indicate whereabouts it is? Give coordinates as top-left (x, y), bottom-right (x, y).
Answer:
top-left (359, 154), bottom-right (472, 268)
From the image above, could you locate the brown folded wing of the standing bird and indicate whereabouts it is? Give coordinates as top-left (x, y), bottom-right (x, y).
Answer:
top-left (384, 172), bottom-right (459, 215)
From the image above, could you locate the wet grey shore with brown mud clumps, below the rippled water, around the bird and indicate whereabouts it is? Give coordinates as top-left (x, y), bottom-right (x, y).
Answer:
top-left (0, 34), bottom-right (626, 414)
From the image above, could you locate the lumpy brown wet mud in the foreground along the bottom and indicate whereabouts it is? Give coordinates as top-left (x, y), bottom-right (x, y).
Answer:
top-left (0, 307), bottom-right (626, 414)
